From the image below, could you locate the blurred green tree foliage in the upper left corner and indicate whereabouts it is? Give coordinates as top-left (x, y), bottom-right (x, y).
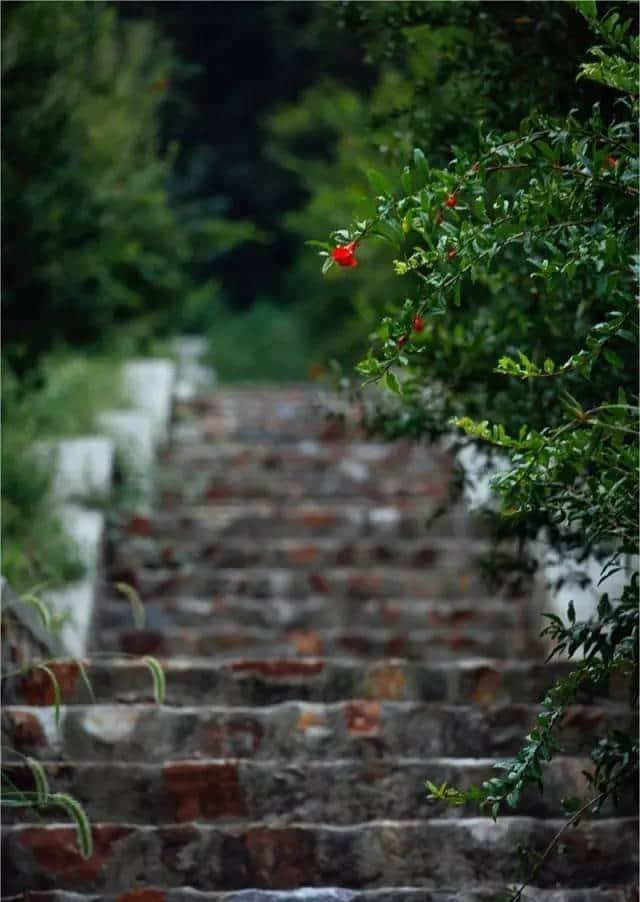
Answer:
top-left (2, 2), bottom-right (188, 369)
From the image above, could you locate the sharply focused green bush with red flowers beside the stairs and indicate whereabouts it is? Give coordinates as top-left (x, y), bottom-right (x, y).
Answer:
top-left (320, 0), bottom-right (639, 888)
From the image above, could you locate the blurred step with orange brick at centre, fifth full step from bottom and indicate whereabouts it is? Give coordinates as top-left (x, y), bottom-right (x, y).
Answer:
top-left (100, 624), bottom-right (535, 662)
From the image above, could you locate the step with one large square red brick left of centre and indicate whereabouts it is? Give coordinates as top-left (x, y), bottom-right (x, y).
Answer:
top-left (4, 758), bottom-right (636, 824)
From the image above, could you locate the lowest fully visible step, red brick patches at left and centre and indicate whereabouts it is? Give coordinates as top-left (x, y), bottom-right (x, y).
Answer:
top-left (3, 817), bottom-right (637, 894)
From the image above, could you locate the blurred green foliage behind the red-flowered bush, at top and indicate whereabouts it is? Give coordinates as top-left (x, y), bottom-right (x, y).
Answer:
top-left (268, 0), bottom-right (608, 368)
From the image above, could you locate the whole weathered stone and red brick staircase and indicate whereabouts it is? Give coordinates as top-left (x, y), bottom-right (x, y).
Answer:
top-left (3, 388), bottom-right (637, 902)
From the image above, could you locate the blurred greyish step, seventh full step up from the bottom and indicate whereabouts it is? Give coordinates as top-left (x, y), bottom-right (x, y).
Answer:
top-left (104, 561), bottom-right (526, 603)
